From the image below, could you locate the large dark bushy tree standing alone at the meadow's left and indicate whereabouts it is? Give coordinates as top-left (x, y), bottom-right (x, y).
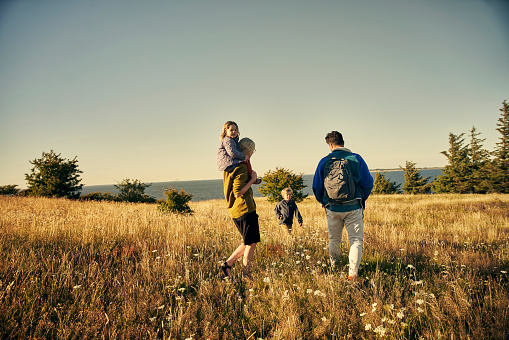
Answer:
top-left (25, 150), bottom-right (83, 198)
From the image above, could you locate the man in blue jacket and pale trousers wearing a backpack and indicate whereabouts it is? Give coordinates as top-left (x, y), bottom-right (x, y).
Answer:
top-left (313, 131), bottom-right (373, 281)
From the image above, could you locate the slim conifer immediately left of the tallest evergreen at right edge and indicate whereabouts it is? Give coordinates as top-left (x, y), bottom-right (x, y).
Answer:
top-left (466, 126), bottom-right (490, 194)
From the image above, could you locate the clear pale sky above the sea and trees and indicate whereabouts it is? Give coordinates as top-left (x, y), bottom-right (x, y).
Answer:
top-left (0, 0), bottom-right (509, 187)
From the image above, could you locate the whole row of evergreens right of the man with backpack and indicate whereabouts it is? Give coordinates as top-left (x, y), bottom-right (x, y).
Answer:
top-left (373, 100), bottom-right (509, 194)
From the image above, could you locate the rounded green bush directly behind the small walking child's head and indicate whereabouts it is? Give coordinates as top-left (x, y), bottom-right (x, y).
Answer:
top-left (258, 167), bottom-right (307, 202)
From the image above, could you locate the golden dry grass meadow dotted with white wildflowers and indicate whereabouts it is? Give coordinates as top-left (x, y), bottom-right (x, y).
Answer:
top-left (0, 195), bottom-right (509, 340)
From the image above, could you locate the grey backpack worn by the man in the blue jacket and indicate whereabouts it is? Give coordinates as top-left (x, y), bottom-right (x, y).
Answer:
top-left (323, 156), bottom-right (355, 204)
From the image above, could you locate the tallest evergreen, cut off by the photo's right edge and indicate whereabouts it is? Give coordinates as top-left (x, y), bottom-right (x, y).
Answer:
top-left (490, 100), bottom-right (509, 194)
